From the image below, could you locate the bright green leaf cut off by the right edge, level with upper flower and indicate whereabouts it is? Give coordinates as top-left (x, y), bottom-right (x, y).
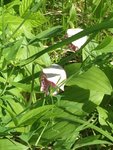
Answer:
top-left (94, 36), bottom-right (113, 53)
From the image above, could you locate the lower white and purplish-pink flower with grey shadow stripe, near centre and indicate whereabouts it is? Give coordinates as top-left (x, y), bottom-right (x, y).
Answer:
top-left (40, 64), bottom-right (66, 95)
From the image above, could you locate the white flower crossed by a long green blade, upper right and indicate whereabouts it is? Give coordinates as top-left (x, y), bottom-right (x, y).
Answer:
top-left (67, 28), bottom-right (87, 50)
